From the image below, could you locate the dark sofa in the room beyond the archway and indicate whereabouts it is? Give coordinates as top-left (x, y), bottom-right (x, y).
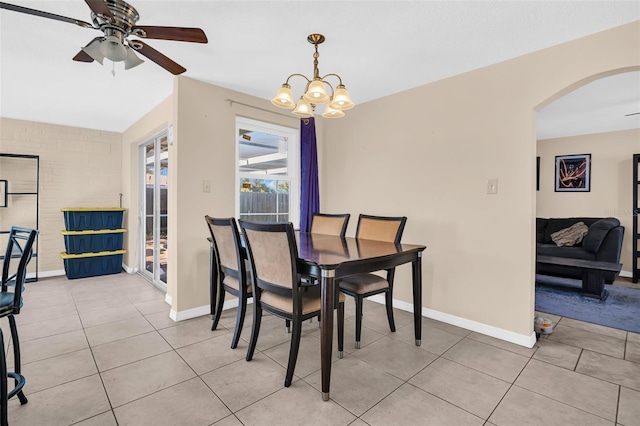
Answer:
top-left (536, 217), bottom-right (624, 284)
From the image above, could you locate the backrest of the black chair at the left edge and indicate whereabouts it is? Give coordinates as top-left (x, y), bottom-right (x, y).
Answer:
top-left (2, 226), bottom-right (38, 314)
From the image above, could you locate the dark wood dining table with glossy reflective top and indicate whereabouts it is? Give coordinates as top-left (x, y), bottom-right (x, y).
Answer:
top-left (298, 232), bottom-right (426, 401)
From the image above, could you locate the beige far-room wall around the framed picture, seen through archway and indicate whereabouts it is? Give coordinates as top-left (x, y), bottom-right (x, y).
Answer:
top-left (536, 129), bottom-right (640, 274)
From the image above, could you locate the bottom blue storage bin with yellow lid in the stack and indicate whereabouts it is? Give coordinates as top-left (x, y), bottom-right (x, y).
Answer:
top-left (60, 250), bottom-right (126, 280)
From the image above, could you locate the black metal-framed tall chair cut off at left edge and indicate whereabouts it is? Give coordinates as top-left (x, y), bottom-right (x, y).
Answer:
top-left (0, 226), bottom-right (38, 426)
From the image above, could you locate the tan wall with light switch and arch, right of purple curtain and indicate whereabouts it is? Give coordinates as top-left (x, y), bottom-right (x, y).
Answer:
top-left (321, 22), bottom-right (640, 336)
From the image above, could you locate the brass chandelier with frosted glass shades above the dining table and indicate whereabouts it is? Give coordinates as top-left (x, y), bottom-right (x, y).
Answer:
top-left (271, 34), bottom-right (353, 118)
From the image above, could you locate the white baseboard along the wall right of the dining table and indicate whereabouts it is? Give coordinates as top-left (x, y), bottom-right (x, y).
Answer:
top-left (367, 294), bottom-right (536, 348)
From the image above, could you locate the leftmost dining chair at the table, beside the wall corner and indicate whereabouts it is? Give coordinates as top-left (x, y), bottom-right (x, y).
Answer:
top-left (205, 216), bottom-right (253, 349)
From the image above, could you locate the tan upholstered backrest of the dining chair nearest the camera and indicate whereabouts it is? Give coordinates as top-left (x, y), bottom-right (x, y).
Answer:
top-left (240, 219), bottom-right (300, 296)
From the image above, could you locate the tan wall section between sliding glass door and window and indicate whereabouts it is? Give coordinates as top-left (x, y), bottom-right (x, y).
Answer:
top-left (169, 77), bottom-right (299, 312)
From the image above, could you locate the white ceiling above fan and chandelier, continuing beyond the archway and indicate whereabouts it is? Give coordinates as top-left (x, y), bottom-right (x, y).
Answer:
top-left (0, 0), bottom-right (640, 138)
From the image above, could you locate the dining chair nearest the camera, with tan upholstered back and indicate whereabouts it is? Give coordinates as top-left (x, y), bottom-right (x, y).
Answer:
top-left (240, 219), bottom-right (345, 387)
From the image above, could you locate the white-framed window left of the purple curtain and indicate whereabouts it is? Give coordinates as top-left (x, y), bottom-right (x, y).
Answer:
top-left (236, 117), bottom-right (300, 228)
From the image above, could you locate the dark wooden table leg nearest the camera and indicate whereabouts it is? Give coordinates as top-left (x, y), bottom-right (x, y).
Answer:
top-left (320, 269), bottom-right (336, 401)
